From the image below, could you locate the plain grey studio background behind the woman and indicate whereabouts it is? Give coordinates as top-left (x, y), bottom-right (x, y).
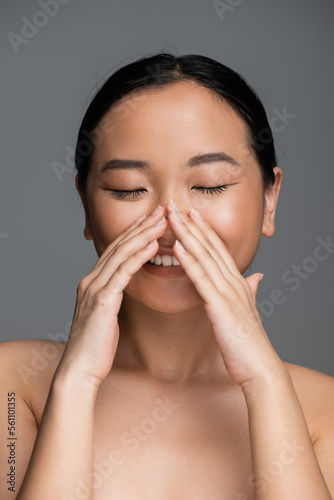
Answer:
top-left (0, 0), bottom-right (334, 375)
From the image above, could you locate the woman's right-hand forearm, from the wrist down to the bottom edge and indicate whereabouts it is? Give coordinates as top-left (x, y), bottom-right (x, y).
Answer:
top-left (243, 367), bottom-right (332, 500)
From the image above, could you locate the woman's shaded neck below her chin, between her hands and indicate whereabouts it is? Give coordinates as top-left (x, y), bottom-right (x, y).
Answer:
top-left (114, 293), bottom-right (228, 382)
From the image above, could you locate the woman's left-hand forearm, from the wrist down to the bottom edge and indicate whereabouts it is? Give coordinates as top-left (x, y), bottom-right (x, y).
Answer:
top-left (17, 376), bottom-right (96, 500)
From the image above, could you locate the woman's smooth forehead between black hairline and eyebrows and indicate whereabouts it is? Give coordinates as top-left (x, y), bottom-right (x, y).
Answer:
top-left (93, 81), bottom-right (249, 167)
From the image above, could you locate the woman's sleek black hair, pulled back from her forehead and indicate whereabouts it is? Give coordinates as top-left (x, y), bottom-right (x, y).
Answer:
top-left (75, 52), bottom-right (277, 192)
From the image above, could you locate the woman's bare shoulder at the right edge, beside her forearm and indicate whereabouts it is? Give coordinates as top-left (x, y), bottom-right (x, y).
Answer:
top-left (285, 362), bottom-right (334, 442)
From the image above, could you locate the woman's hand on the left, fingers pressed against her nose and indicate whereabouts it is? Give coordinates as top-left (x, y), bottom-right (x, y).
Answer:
top-left (55, 206), bottom-right (170, 389)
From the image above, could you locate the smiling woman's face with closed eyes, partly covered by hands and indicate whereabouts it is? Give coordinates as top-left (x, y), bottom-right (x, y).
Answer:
top-left (77, 82), bottom-right (282, 311)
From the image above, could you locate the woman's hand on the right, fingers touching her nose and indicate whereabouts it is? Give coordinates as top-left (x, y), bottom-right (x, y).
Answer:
top-left (167, 198), bottom-right (285, 387)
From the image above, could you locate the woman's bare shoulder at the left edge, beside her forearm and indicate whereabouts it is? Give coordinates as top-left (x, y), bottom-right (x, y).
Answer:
top-left (0, 339), bottom-right (65, 500)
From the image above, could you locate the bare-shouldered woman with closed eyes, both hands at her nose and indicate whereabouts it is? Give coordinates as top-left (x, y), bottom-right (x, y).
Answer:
top-left (1, 53), bottom-right (334, 500)
